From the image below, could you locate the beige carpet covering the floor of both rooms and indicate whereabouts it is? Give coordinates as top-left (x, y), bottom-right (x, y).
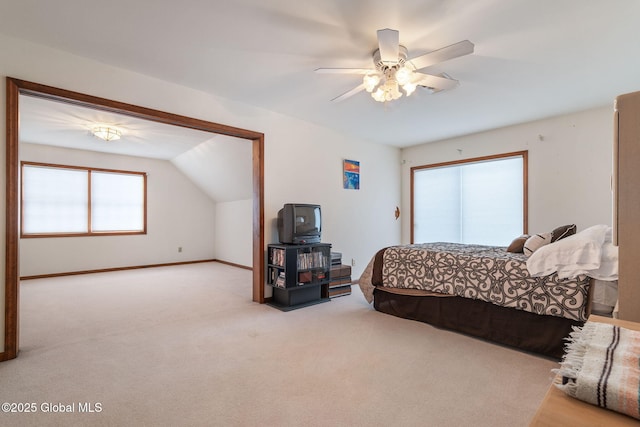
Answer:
top-left (0, 263), bottom-right (557, 427)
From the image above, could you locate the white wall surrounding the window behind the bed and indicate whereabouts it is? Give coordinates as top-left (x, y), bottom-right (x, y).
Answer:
top-left (402, 106), bottom-right (613, 243)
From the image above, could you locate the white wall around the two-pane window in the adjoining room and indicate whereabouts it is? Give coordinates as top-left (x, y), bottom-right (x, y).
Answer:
top-left (19, 143), bottom-right (215, 276)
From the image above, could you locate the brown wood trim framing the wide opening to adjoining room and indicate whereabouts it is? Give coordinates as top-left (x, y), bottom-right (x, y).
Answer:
top-left (0, 77), bottom-right (265, 361)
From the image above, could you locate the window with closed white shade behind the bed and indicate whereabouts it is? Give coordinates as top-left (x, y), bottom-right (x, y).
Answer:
top-left (411, 151), bottom-right (527, 246)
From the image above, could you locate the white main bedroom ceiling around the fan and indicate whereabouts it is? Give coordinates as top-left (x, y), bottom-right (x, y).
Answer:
top-left (0, 0), bottom-right (640, 147)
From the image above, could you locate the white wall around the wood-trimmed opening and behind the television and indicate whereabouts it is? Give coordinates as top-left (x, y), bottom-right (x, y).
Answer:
top-left (0, 35), bottom-right (400, 354)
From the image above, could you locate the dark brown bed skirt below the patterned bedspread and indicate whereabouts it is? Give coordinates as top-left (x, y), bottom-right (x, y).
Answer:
top-left (373, 288), bottom-right (584, 360)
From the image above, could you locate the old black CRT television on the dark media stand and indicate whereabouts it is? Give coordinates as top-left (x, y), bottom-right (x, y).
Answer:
top-left (278, 203), bottom-right (322, 244)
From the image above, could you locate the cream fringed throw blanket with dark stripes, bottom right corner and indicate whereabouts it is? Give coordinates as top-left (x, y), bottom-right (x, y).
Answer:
top-left (555, 322), bottom-right (640, 419)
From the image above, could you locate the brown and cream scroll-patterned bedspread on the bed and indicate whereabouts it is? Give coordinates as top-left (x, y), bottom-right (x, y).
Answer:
top-left (363, 243), bottom-right (589, 321)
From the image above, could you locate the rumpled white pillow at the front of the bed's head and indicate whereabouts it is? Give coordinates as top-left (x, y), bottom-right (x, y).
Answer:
top-left (527, 225), bottom-right (611, 278)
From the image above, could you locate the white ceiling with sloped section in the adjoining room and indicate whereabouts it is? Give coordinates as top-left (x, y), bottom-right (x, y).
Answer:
top-left (20, 96), bottom-right (252, 202)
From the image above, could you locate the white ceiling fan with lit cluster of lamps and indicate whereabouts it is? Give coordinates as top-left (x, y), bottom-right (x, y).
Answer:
top-left (315, 28), bottom-right (474, 102)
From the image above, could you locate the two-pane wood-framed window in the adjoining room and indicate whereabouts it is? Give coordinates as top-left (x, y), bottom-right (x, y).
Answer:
top-left (20, 162), bottom-right (147, 237)
